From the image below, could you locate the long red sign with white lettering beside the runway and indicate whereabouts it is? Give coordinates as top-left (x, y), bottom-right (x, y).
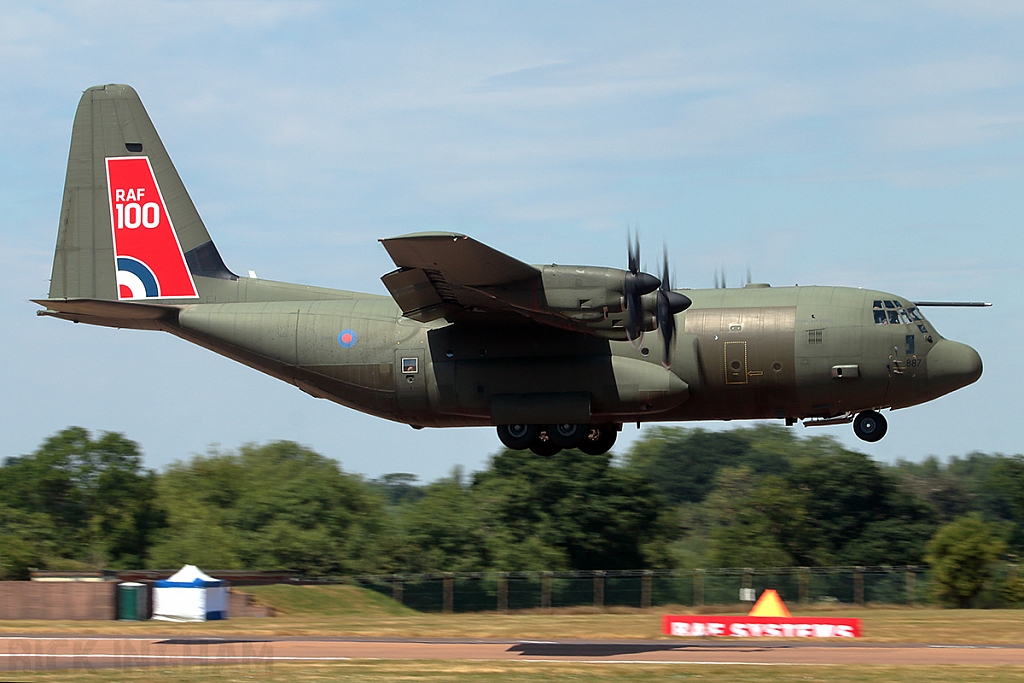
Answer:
top-left (662, 614), bottom-right (860, 638)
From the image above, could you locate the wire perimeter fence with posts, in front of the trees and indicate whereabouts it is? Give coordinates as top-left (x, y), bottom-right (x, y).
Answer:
top-left (302, 566), bottom-right (966, 612)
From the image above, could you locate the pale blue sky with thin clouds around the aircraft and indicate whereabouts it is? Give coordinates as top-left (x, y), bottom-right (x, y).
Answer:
top-left (0, 1), bottom-right (1024, 479)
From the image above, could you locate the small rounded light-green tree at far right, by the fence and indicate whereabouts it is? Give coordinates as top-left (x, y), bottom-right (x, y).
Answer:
top-left (926, 512), bottom-right (1006, 607)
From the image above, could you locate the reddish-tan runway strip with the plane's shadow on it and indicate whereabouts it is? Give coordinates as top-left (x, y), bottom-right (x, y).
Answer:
top-left (6, 635), bottom-right (1024, 671)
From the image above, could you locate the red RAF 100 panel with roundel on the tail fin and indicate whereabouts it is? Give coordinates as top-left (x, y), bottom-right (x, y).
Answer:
top-left (106, 157), bottom-right (198, 300)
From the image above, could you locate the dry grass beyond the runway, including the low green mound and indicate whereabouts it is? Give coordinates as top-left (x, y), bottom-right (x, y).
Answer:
top-left (0, 586), bottom-right (1024, 645)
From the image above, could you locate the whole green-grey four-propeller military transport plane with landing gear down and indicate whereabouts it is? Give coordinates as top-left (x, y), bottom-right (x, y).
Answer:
top-left (37, 85), bottom-right (984, 455)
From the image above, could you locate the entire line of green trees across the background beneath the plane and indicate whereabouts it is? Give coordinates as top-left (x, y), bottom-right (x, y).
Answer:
top-left (0, 426), bottom-right (1024, 602)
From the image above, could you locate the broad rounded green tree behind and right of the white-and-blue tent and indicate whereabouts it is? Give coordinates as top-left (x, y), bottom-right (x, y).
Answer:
top-left (153, 441), bottom-right (392, 574)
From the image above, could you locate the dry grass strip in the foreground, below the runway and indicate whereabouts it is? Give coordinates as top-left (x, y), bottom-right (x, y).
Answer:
top-left (6, 660), bottom-right (1024, 683)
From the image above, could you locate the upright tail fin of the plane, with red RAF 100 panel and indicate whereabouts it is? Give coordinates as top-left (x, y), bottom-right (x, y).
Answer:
top-left (49, 85), bottom-right (238, 303)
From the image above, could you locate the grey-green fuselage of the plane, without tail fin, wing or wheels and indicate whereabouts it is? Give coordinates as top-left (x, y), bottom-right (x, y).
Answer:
top-left (83, 278), bottom-right (981, 427)
